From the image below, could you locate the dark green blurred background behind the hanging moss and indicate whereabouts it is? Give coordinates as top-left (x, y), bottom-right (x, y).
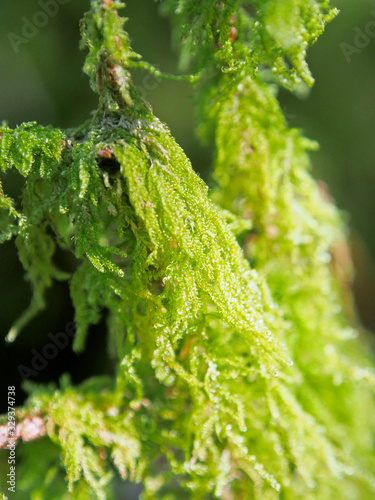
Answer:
top-left (0, 0), bottom-right (375, 412)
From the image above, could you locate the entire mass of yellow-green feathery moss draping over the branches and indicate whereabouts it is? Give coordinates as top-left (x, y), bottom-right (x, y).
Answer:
top-left (0, 0), bottom-right (375, 500)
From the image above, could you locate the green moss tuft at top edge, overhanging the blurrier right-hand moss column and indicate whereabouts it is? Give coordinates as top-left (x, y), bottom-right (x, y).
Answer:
top-left (162, 0), bottom-right (338, 88)
